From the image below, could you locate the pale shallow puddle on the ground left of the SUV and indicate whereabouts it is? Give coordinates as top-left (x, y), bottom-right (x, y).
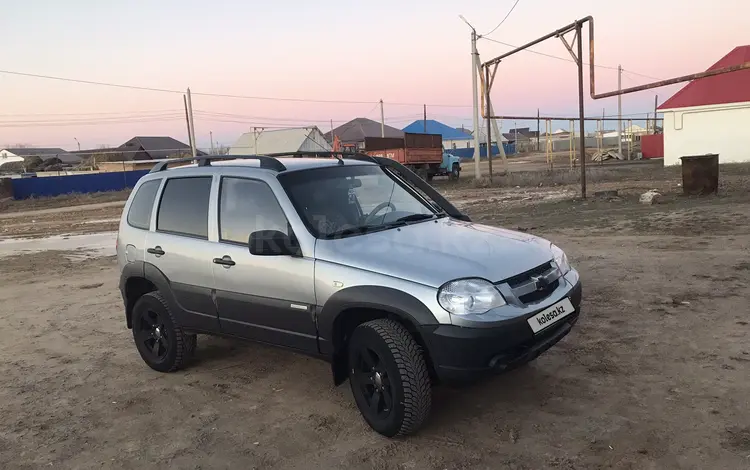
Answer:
top-left (0, 232), bottom-right (117, 261)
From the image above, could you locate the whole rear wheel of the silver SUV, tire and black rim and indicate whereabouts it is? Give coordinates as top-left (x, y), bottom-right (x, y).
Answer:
top-left (133, 292), bottom-right (197, 372)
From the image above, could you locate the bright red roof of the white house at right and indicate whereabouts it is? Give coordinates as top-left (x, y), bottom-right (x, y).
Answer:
top-left (659, 46), bottom-right (750, 109)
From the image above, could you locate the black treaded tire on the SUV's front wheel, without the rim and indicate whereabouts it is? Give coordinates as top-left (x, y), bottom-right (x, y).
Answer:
top-left (349, 319), bottom-right (432, 437)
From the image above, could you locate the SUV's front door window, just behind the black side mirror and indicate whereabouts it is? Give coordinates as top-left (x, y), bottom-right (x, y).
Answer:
top-left (219, 177), bottom-right (290, 243)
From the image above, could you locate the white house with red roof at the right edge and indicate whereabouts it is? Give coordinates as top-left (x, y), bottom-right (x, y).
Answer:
top-left (658, 45), bottom-right (750, 165)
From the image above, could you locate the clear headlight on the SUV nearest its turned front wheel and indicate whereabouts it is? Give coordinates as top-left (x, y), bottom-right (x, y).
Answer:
top-left (438, 279), bottom-right (506, 315)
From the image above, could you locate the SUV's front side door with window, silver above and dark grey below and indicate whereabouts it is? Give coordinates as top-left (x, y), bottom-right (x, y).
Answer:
top-left (212, 176), bottom-right (318, 352)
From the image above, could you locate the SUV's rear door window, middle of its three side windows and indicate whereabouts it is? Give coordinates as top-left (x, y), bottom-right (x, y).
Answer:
top-left (156, 176), bottom-right (211, 238)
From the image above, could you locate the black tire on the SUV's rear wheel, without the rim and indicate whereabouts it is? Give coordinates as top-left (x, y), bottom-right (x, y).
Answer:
top-left (133, 292), bottom-right (197, 372)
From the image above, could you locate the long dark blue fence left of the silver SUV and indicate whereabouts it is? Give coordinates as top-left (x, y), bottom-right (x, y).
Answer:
top-left (12, 170), bottom-right (149, 199)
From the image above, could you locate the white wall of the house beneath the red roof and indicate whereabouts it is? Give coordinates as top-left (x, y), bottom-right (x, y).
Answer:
top-left (663, 102), bottom-right (750, 165)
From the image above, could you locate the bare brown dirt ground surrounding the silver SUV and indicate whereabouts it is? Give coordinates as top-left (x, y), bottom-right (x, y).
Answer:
top-left (0, 162), bottom-right (750, 470)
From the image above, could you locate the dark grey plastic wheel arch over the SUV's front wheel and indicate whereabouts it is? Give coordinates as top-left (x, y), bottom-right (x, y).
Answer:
top-left (318, 286), bottom-right (438, 385)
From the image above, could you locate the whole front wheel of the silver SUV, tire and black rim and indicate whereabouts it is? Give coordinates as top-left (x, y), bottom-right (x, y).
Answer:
top-left (349, 319), bottom-right (432, 437)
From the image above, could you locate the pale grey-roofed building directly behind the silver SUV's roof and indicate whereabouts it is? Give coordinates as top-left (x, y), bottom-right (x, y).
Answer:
top-left (229, 126), bottom-right (331, 155)
